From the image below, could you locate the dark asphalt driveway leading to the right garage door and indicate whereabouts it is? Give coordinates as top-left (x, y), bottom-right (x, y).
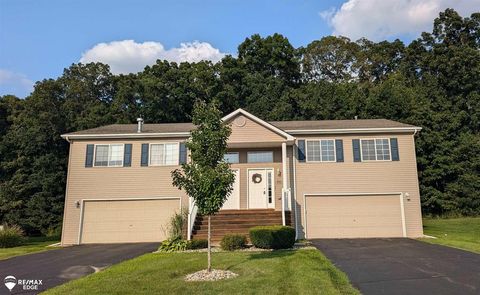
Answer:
top-left (312, 239), bottom-right (480, 295)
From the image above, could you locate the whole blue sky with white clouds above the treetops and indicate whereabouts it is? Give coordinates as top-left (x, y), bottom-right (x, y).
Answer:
top-left (0, 0), bottom-right (480, 97)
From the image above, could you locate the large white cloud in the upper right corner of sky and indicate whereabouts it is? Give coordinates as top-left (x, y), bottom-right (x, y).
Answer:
top-left (320, 0), bottom-right (480, 41)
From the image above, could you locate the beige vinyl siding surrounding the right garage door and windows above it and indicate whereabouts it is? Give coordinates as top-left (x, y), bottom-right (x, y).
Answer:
top-left (296, 133), bottom-right (423, 237)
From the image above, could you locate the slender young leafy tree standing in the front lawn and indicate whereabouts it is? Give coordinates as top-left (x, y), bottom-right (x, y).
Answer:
top-left (172, 101), bottom-right (235, 272)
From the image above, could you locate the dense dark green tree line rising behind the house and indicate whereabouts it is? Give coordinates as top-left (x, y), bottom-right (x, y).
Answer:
top-left (0, 9), bottom-right (480, 234)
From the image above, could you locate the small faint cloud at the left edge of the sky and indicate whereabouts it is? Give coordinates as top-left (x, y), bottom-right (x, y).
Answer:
top-left (0, 69), bottom-right (34, 97)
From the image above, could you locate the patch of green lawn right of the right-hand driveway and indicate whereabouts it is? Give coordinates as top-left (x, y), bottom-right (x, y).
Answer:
top-left (421, 217), bottom-right (480, 253)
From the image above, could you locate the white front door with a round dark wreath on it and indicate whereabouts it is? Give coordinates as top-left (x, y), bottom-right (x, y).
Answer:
top-left (248, 168), bottom-right (275, 209)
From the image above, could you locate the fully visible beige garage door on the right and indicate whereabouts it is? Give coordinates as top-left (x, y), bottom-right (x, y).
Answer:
top-left (305, 194), bottom-right (404, 239)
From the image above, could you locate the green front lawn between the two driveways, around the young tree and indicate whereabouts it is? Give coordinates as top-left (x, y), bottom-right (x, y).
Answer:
top-left (45, 249), bottom-right (359, 295)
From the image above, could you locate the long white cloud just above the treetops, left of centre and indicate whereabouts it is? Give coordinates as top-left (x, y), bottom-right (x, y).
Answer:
top-left (80, 40), bottom-right (229, 74)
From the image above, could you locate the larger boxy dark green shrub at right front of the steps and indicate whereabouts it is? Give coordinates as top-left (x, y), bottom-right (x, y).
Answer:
top-left (250, 225), bottom-right (295, 249)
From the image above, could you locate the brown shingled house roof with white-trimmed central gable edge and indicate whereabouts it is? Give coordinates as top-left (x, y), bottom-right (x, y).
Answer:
top-left (62, 109), bottom-right (421, 140)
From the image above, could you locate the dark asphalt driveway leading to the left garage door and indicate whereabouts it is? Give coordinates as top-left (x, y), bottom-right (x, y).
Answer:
top-left (0, 243), bottom-right (159, 294)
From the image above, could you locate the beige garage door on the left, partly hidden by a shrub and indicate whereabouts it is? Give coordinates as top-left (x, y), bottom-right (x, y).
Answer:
top-left (80, 198), bottom-right (180, 244)
